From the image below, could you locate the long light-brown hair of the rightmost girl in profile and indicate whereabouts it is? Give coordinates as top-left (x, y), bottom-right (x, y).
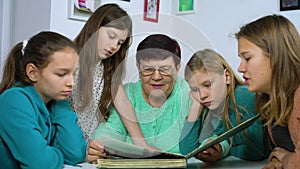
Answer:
top-left (236, 15), bottom-right (300, 125)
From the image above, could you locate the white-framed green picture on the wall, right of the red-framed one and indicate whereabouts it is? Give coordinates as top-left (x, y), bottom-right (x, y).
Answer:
top-left (172, 0), bottom-right (197, 15)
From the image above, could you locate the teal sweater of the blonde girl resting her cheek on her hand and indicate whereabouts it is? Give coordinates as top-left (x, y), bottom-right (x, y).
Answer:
top-left (180, 86), bottom-right (270, 161)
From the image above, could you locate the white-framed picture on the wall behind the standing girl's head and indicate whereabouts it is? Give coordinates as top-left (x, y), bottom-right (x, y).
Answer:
top-left (68, 0), bottom-right (101, 21)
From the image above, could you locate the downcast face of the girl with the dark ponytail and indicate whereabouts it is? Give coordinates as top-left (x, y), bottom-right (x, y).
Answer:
top-left (33, 48), bottom-right (78, 103)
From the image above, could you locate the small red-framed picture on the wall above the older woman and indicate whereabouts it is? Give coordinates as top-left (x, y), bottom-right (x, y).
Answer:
top-left (144, 0), bottom-right (160, 22)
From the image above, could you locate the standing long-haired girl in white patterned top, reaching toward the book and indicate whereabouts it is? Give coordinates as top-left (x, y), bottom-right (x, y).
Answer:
top-left (69, 4), bottom-right (156, 157)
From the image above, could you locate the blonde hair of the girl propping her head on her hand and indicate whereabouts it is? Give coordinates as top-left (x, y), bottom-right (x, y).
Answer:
top-left (185, 49), bottom-right (243, 129)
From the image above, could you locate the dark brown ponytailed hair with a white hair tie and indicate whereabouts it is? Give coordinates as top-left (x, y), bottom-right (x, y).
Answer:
top-left (0, 31), bottom-right (75, 94)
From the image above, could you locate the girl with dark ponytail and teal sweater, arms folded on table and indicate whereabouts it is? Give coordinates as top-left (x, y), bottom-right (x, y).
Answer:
top-left (0, 32), bottom-right (86, 169)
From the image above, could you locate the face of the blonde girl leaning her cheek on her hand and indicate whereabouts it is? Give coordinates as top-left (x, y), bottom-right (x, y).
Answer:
top-left (188, 71), bottom-right (230, 110)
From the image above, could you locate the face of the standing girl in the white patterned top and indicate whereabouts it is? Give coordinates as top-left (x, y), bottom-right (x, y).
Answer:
top-left (98, 26), bottom-right (128, 59)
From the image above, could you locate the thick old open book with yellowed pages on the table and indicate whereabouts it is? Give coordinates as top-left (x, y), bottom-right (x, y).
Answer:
top-left (98, 114), bottom-right (260, 168)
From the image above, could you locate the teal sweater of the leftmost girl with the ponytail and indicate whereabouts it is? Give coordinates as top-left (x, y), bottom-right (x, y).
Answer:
top-left (0, 85), bottom-right (86, 169)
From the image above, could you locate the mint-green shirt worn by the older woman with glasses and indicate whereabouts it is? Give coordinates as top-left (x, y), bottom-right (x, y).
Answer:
top-left (93, 78), bottom-right (191, 153)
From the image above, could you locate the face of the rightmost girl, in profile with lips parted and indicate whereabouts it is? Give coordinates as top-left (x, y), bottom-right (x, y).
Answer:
top-left (238, 38), bottom-right (271, 93)
